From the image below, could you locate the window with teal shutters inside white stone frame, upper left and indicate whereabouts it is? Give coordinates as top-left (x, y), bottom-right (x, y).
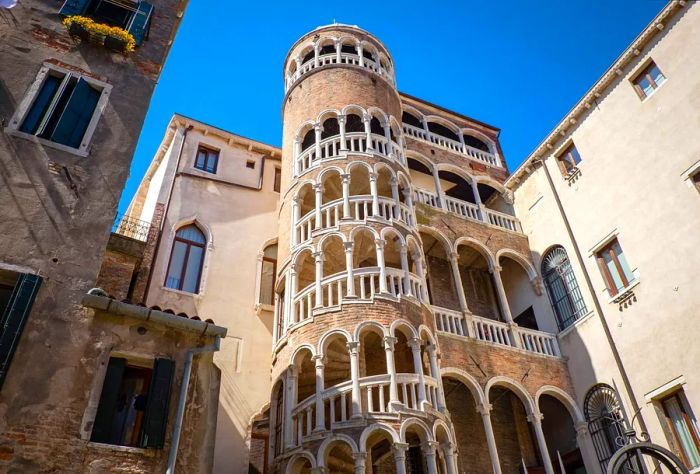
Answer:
top-left (18, 67), bottom-right (103, 149)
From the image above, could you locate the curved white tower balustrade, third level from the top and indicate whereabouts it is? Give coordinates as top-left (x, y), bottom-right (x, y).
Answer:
top-left (295, 195), bottom-right (415, 245)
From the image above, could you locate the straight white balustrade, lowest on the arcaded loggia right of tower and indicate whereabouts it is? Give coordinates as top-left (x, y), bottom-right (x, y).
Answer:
top-left (432, 306), bottom-right (561, 357)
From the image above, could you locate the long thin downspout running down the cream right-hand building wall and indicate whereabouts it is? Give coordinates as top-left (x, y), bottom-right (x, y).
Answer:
top-left (534, 158), bottom-right (648, 433)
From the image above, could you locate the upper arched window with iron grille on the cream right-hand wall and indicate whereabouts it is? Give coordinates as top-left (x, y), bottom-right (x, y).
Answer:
top-left (542, 246), bottom-right (587, 330)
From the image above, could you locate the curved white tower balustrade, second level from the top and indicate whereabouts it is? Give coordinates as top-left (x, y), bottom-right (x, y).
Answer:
top-left (294, 132), bottom-right (406, 175)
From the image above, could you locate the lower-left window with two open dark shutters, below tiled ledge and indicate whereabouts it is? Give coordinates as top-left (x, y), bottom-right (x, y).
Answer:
top-left (90, 357), bottom-right (175, 448)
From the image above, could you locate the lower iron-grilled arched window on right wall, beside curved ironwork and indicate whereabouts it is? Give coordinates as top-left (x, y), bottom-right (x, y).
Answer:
top-left (583, 383), bottom-right (641, 472)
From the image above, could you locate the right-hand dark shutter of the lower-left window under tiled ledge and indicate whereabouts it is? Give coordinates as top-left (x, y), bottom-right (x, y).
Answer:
top-left (141, 359), bottom-right (175, 449)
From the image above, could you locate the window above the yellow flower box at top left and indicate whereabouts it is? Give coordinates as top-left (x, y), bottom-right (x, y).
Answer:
top-left (59, 0), bottom-right (153, 46)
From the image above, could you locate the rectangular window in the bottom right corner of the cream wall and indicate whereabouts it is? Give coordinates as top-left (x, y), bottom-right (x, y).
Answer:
top-left (660, 390), bottom-right (700, 469)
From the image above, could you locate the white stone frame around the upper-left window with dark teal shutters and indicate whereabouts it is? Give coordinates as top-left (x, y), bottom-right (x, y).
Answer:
top-left (5, 63), bottom-right (112, 157)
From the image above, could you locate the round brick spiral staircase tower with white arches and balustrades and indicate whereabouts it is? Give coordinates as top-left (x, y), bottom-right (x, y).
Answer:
top-left (270, 25), bottom-right (455, 473)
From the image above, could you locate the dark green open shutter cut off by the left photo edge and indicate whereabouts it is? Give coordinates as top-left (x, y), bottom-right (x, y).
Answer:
top-left (0, 274), bottom-right (41, 388)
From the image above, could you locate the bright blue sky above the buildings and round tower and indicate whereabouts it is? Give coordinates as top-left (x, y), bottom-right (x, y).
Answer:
top-left (119, 0), bottom-right (666, 211)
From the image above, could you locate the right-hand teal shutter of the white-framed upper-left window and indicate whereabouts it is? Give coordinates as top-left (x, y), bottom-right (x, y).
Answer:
top-left (51, 77), bottom-right (100, 148)
